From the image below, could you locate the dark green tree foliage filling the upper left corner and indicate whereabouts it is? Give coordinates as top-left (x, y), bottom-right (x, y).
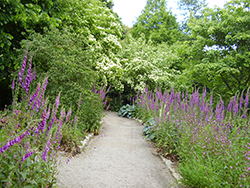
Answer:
top-left (0, 0), bottom-right (67, 106)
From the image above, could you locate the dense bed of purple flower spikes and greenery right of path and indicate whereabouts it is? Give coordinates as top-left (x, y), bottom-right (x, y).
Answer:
top-left (137, 88), bottom-right (250, 187)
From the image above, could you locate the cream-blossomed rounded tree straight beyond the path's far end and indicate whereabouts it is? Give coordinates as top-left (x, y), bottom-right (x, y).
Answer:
top-left (116, 34), bottom-right (180, 99)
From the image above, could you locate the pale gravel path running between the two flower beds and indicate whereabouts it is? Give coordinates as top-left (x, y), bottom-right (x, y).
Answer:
top-left (58, 112), bottom-right (178, 188)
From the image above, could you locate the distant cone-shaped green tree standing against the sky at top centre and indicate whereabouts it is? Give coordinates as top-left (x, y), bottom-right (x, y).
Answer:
top-left (131, 0), bottom-right (181, 44)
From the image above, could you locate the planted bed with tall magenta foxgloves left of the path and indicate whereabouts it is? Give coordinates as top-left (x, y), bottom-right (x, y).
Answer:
top-left (0, 51), bottom-right (106, 187)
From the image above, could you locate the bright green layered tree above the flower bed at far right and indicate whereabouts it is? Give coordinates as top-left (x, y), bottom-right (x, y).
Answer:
top-left (183, 0), bottom-right (250, 100)
